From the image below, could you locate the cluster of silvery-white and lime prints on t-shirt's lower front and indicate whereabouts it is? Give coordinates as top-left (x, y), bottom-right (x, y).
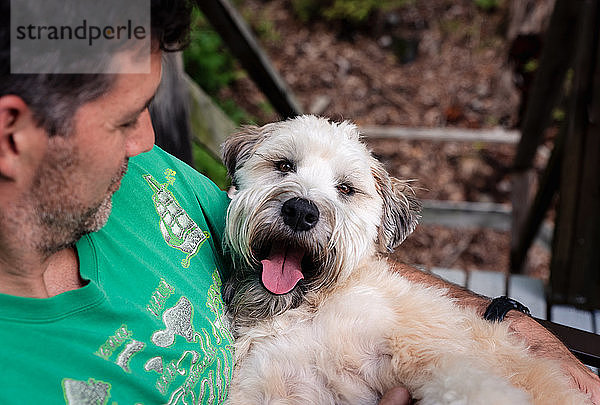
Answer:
top-left (62, 268), bottom-right (233, 405)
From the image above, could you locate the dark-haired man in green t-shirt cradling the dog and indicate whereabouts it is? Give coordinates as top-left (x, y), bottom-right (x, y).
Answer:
top-left (0, 0), bottom-right (600, 404)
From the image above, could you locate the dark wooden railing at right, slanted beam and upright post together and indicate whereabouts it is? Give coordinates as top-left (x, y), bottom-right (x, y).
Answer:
top-left (511, 0), bottom-right (600, 308)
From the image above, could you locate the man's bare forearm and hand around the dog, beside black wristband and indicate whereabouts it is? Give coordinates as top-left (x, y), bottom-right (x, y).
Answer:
top-left (393, 263), bottom-right (600, 405)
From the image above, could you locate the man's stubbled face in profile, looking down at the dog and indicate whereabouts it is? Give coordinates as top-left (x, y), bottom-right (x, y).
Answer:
top-left (29, 53), bottom-right (161, 254)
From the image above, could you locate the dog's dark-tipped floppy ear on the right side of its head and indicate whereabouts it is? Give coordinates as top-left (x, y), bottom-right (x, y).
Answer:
top-left (371, 162), bottom-right (421, 252)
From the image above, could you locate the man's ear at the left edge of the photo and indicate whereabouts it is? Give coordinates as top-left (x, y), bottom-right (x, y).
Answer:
top-left (0, 95), bottom-right (48, 180)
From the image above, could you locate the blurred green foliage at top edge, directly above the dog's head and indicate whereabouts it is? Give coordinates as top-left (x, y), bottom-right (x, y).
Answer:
top-left (292, 0), bottom-right (411, 24)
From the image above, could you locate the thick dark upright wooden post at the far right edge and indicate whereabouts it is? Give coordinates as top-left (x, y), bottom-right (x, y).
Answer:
top-left (550, 0), bottom-right (600, 308)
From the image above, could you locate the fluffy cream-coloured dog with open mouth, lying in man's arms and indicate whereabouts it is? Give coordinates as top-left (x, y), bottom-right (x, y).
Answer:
top-left (223, 116), bottom-right (591, 405)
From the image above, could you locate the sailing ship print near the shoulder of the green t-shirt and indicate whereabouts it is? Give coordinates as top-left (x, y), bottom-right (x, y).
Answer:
top-left (142, 169), bottom-right (209, 269)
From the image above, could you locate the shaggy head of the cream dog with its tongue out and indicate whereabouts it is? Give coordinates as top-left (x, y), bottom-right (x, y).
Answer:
top-left (223, 116), bottom-right (420, 322)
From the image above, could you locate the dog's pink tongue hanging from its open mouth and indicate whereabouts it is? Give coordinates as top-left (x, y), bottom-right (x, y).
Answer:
top-left (261, 246), bottom-right (304, 294)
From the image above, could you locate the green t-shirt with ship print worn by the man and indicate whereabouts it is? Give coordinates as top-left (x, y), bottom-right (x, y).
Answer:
top-left (0, 147), bottom-right (233, 405)
